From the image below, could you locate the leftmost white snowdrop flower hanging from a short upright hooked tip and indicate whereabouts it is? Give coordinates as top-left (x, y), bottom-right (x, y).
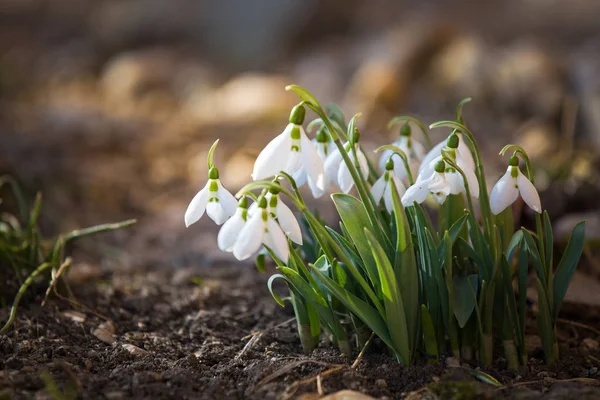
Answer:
top-left (184, 167), bottom-right (237, 227)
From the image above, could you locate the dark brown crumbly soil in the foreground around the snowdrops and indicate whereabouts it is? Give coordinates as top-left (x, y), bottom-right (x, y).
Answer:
top-left (0, 258), bottom-right (600, 399)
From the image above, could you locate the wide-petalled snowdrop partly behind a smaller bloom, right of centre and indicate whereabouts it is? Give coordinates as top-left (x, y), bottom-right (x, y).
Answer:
top-left (417, 133), bottom-right (479, 198)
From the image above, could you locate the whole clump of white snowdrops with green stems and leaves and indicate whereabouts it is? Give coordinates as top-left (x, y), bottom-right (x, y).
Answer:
top-left (185, 85), bottom-right (585, 367)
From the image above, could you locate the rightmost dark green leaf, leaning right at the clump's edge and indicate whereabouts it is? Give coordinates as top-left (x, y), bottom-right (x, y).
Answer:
top-left (552, 221), bottom-right (586, 318)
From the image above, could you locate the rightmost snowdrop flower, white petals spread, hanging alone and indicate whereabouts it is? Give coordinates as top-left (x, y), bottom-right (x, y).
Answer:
top-left (490, 156), bottom-right (542, 215)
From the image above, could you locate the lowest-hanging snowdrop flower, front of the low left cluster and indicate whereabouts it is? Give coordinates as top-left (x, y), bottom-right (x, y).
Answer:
top-left (233, 197), bottom-right (290, 263)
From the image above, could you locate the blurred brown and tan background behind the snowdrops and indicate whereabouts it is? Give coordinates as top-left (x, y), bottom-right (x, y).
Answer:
top-left (0, 0), bottom-right (600, 274)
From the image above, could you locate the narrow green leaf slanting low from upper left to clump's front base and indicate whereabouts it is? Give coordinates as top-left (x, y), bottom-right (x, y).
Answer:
top-left (312, 266), bottom-right (394, 349)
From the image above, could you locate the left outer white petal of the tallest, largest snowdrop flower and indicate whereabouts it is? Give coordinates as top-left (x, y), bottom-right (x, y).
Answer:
top-left (252, 124), bottom-right (294, 181)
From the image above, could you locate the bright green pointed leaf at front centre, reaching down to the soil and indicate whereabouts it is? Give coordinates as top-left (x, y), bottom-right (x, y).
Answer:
top-left (365, 229), bottom-right (416, 365)
